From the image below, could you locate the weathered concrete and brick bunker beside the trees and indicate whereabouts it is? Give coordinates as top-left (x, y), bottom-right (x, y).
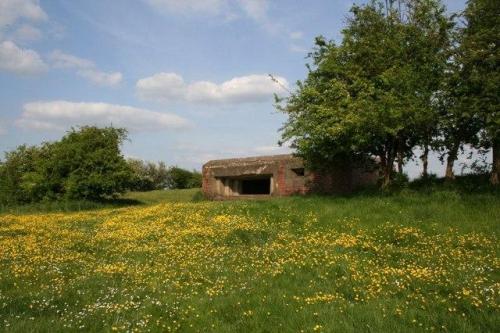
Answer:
top-left (202, 155), bottom-right (377, 199)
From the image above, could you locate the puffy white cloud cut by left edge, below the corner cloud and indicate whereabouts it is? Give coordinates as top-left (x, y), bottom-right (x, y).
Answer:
top-left (0, 41), bottom-right (47, 75)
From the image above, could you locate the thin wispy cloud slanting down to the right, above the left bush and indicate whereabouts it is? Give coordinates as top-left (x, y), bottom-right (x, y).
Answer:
top-left (49, 50), bottom-right (123, 86)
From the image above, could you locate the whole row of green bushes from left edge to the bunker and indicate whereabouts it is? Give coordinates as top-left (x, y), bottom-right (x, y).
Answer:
top-left (0, 126), bottom-right (201, 205)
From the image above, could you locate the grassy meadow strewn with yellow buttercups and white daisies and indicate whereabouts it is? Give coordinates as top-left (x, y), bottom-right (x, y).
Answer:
top-left (0, 185), bottom-right (500, 332)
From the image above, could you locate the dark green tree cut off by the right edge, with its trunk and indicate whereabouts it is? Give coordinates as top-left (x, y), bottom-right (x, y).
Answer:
top-left (459, 0), bottom-right (500, 185)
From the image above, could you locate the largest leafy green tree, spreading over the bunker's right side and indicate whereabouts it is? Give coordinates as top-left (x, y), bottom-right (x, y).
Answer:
top-left (277, 0), bottom-right (450, 186)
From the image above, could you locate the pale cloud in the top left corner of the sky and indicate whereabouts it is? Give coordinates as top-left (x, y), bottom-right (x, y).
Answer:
top-left (0, 0), bottom-right (47, 28)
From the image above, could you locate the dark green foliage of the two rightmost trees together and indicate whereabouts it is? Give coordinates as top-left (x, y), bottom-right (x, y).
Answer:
top-left (435, 0), bottom-right (500, 178)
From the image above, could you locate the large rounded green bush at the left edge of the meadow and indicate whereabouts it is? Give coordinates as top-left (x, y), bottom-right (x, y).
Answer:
top-left (0, 126), bottom-right (132, 203)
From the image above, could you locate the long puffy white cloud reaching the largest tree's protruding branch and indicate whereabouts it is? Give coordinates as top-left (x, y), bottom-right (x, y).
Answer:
top-left (136, 73), bottom-right (288, 104)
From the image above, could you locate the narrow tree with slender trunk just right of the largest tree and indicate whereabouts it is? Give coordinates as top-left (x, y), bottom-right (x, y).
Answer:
top-left (403, 0), bottom-right (455, 177)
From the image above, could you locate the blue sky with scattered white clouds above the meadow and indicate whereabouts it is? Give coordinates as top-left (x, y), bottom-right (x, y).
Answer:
top-left (0, 0), bottom-right (465, 176)
